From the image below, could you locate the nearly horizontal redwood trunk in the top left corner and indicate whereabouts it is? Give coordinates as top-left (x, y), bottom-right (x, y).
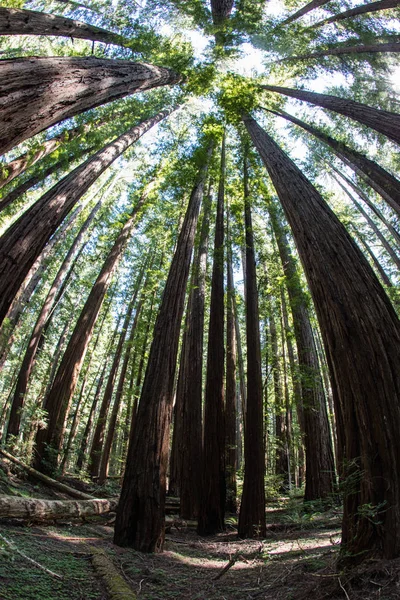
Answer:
top-left (0, 6), bottom-right (128, 47)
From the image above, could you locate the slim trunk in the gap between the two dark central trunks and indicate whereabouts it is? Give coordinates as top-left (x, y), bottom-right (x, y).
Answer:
top-left (225, 205), bottom-right (238, 513)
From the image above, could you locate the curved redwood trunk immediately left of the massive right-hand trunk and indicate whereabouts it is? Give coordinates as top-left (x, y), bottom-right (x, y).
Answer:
top-left (268, 202), bottom-right (335, 501)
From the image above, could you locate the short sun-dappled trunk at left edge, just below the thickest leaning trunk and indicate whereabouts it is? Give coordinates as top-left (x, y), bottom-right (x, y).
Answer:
top-left (0, 122), bottom-right (87, 188)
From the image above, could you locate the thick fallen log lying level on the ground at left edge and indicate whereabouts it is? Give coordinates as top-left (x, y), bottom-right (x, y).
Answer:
top-left (0, 496), bottom-right (118, 521)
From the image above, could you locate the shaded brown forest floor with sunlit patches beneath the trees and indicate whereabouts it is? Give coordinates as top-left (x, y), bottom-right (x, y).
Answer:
top-left (0, 465), bottom-right (400, 600)
